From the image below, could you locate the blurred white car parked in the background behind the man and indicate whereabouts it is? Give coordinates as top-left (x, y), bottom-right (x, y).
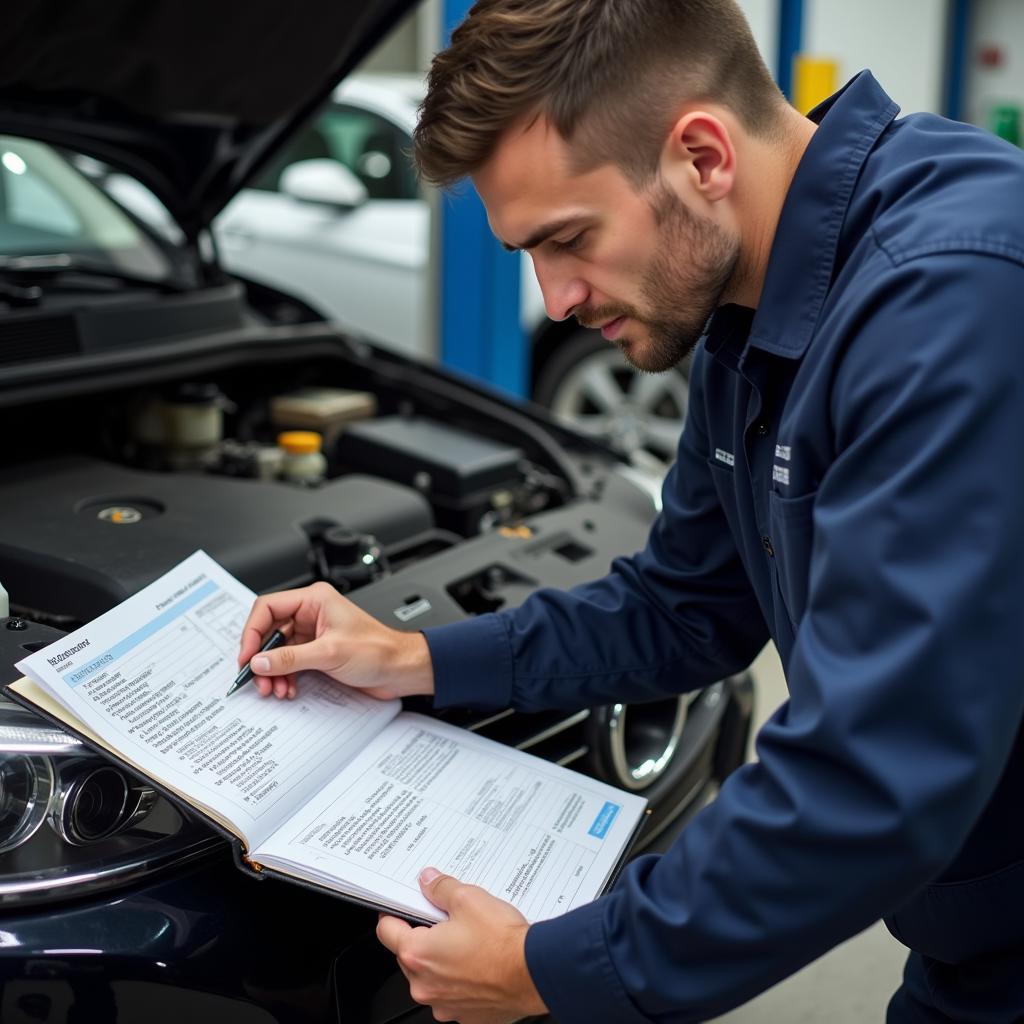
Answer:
top-left (214, 75), bottom-right (688, 470)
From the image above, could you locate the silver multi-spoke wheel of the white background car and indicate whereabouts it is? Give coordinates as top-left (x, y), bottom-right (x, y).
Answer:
top-left (535, 330), bottom-right (689, 466)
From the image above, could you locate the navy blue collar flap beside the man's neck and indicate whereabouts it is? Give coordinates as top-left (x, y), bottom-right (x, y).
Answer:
top-left (749, 71), bottom-right (899, 358)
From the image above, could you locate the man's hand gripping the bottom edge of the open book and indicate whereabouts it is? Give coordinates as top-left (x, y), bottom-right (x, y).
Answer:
top-left (377, 867), bottom-right (547, 1024)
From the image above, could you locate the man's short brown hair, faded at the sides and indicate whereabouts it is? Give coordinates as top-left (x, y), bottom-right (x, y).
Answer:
top-left (414, 0), bottom-right (784, 185)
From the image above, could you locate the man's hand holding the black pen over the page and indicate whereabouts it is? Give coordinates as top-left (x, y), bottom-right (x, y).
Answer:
top-left (239, 583), bottom-right (434, 699)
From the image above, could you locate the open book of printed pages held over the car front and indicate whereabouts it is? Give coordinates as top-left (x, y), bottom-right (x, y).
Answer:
top-left (8, 552), bottom-right (646, 921)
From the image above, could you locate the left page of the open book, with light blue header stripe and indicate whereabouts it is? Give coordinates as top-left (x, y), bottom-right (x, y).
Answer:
top-left (14, 552), bottom-right (400, 849)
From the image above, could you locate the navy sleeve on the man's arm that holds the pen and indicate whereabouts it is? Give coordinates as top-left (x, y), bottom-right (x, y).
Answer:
top-left (424, 344), bottom-right (768, 711)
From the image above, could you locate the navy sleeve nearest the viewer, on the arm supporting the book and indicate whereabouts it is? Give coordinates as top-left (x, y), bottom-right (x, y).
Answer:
top-left (526, 253), bottom-right (1024, 1024)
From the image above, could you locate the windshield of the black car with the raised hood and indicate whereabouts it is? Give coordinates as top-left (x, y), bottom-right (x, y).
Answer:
top-left (0, 135), bottom-right (171, 280)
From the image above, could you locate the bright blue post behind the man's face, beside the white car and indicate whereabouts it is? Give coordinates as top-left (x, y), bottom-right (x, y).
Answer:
top-left (437, 0), bottom-right (529, 396)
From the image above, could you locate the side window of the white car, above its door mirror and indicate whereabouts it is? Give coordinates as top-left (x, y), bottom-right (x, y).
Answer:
top-left (253, 105), bottom-right (420, 199)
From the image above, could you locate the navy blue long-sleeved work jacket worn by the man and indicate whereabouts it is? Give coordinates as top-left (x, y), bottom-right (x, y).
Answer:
top-left (426, 73), bottom-right (1024, 1024)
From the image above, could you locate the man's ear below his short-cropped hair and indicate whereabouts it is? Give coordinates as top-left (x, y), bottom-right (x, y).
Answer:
top-left (660, 110), bottom-right (736, 203)
